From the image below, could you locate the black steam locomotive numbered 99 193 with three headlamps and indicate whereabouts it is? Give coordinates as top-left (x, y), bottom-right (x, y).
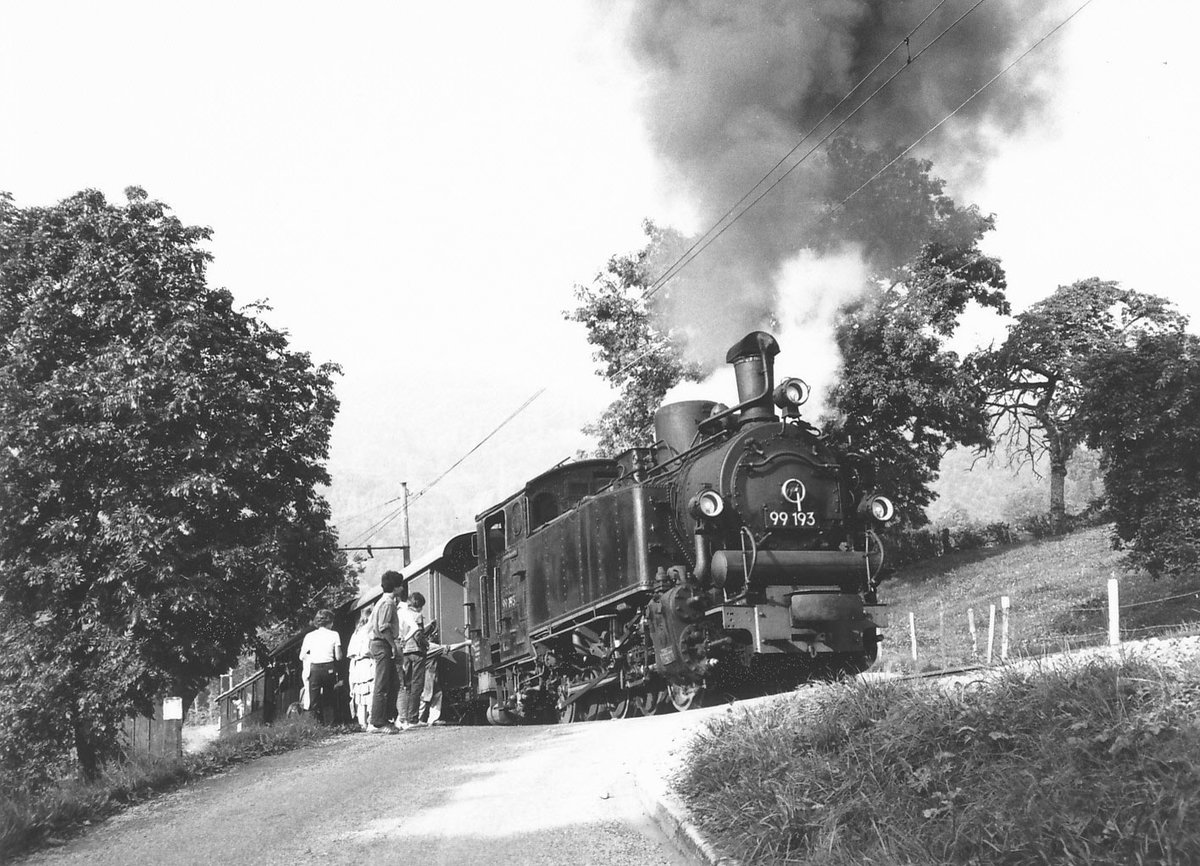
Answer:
top-left (466, 331), bottom-right (893, 724)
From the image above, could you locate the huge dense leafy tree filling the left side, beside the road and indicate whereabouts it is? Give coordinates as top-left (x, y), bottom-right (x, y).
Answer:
top-left (0, 188), bottom-right (352, 774)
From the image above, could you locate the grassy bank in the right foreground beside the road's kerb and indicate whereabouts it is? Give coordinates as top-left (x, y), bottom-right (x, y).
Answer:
top-left (677, 657), bottom-right (1200, 866)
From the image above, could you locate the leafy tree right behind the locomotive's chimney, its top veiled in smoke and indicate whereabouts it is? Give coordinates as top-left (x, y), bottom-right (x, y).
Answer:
top-left (814, 139), bottom-right (1008, 525)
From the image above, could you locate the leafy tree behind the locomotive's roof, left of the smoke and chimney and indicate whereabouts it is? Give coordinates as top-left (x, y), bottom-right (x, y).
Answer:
top-left (565, 221), bottom-right (701, 456)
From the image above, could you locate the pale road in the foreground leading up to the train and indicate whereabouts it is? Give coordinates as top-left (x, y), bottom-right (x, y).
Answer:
top-left (19, 710), bottom-right (709, 866)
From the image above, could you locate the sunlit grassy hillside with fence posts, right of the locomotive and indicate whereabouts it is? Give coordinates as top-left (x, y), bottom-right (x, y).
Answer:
top-left (877, 525), bottom-right (1200, 670)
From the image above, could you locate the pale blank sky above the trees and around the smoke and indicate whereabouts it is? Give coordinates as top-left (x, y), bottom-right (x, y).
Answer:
top-left (0, 0), bottom-right (1200, 580)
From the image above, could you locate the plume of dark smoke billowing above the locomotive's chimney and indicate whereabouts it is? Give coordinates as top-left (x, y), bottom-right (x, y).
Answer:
top-left (630, 0), bottom-right (1055, 362)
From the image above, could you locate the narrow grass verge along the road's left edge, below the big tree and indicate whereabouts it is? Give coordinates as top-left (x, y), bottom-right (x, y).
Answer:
top-left (0, 720), bottom-right (330, 862)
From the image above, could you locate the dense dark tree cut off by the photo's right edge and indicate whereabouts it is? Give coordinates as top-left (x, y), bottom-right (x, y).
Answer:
top-left (1073, 330), bottom-right (1200, 576)
